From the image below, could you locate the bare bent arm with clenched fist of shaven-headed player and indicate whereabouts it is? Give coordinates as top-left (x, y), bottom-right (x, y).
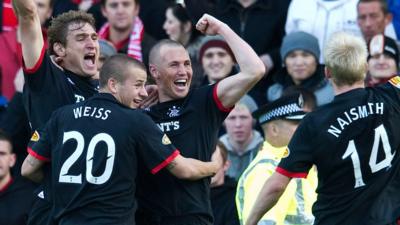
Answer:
top-left (196, 14), bottom-right (265, 108)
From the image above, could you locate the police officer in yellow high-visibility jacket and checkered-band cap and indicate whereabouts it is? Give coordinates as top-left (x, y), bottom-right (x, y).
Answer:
top-left (236, 92), bottom-right (317, 225)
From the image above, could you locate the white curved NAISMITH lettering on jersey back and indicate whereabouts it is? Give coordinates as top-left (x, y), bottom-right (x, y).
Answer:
top-left (328, 102), bottom-right (383, 137)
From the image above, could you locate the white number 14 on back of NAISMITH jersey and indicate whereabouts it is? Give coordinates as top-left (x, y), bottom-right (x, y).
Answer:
top-left (342, 125), bottom-right (396, 188)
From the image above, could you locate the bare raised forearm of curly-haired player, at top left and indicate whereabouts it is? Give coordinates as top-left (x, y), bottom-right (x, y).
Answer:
top-left (12, 0), bottom-right (44, 69)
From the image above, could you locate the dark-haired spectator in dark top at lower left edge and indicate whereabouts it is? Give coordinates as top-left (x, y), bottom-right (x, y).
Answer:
top-left (0, 131), bottom-right (35, 225)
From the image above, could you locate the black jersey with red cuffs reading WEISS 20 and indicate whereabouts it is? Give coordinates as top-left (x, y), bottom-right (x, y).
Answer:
top-left (30, 93), bottom-right (179, 225)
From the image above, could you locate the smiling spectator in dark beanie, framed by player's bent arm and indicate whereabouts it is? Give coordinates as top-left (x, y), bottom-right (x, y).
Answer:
top-left (198, 36), bottom-right (238, 86)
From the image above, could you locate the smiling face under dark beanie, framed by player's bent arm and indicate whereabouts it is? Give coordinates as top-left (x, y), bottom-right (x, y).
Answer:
top-left (202, 47), bottom-right (235, 83)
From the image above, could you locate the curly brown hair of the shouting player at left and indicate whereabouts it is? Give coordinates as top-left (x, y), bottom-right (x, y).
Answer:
top-left (47, 10), bottom-right (96, 55)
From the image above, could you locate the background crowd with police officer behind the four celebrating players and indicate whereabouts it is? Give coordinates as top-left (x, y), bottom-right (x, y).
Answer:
top-left (0, 0), bottom-right (400, 225)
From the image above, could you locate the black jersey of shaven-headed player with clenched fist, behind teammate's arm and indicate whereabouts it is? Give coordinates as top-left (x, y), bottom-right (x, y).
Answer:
top-left (137, 85), bottom-right (231, 223)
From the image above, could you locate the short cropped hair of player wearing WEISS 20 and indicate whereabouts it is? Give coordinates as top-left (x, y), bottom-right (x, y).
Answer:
top-left (99, 54), bottom-right (146, 88)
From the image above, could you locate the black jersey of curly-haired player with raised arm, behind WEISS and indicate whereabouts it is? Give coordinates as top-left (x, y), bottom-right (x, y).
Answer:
top-left (23, 47), bottom-right (97, 130)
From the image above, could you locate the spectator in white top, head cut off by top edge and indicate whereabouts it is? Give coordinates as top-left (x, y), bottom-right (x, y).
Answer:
top-left (285, 0), bottom-right (361, 63)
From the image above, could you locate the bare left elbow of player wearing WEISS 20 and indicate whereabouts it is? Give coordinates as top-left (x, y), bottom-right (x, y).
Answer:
top-left (21, 155), bottom-right (44, 183)
